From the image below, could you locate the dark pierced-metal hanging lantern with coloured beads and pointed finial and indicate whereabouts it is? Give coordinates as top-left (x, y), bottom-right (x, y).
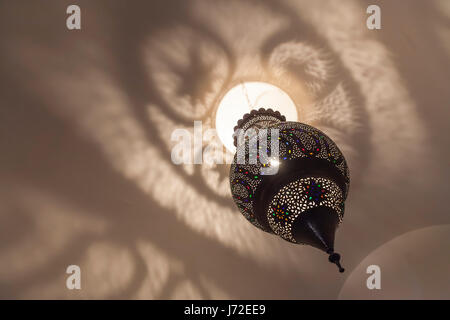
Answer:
top-left (230, 109), bottom-right (350, 272)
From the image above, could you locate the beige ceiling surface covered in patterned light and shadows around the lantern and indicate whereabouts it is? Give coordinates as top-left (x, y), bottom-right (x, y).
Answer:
top-left (0, 0), bottom-right (450, 299)
